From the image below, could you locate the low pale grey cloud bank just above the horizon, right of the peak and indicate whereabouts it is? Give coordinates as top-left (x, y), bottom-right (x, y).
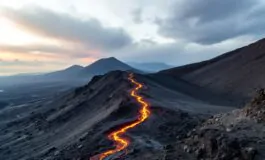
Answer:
top-left (115, 37), bottom-right (253, 66)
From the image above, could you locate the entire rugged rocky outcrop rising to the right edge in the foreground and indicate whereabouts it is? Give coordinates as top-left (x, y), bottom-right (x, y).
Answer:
top-left (181, 89), bottom-right (265, 160)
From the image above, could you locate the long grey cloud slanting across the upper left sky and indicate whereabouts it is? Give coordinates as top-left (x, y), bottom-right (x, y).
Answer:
top-left (1, 7), bottom-right (132, 50)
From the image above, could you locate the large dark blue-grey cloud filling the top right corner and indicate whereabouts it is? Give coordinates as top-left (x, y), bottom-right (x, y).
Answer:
top-left (157, 0), bottom-right (265, 44)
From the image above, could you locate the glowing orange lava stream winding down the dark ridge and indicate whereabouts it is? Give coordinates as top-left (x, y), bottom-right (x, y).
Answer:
top-left (90, 73), bottom-right (151, 160)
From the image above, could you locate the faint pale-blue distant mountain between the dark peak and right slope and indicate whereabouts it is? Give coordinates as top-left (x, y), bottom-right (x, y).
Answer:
top-left (128, 62), bottom-right (173, 72)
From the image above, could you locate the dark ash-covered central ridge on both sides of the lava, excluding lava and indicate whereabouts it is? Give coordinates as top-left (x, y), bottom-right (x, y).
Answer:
top-left (0, 71), bottom-right (233, 160)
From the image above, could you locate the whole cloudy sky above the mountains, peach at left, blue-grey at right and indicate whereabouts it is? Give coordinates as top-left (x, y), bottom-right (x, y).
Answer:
top-left (0, 0), bottom-right (265, 75)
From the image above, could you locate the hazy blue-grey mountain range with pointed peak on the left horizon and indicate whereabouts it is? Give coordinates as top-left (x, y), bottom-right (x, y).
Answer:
top-left (0, 57), bottom-right (138, 84)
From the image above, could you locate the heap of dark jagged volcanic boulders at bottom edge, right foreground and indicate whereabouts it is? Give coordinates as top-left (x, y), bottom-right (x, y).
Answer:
top-left (184, 129), bottom-right (257, 160)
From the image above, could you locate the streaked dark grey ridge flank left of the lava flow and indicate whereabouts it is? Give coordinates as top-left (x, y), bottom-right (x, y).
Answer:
top-left (0, 72), bottom-right (129, 160)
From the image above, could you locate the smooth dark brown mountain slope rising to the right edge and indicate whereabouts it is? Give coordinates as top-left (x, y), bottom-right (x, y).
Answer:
top-left (161, 39), bottom-right (265, 104)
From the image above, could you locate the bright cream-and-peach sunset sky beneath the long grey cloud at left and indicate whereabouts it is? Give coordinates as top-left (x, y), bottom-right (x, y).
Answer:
top-left (0, 8), bottom-right (98, 76)
